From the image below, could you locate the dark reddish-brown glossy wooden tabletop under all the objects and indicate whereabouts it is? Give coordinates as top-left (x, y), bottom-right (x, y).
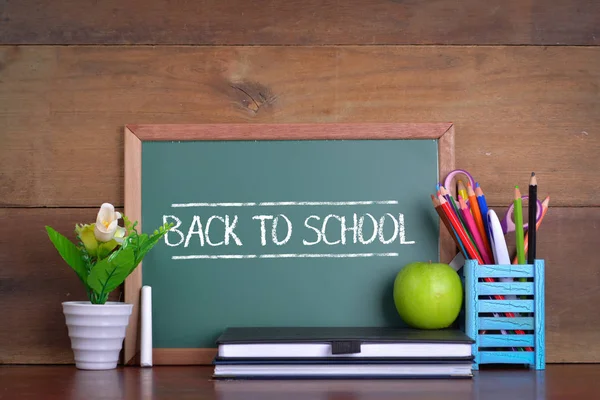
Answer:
top-left (0, 364), bottom-right (600, 400)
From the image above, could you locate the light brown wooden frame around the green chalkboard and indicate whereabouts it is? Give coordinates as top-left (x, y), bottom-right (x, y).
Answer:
top-left (124, 122), bottom-right (456, 365)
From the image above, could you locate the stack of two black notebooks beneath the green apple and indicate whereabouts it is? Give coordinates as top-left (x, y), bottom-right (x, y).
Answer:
top-left (213, 327), bottom-right (473, 379)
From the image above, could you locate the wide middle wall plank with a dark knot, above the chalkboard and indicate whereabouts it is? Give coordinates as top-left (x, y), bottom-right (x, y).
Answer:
top-left (0, 46), bottom-right (600, 207)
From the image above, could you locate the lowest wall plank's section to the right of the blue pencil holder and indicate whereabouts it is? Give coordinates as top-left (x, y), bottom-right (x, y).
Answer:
top-left (537, 203), bottom-right (600, 363)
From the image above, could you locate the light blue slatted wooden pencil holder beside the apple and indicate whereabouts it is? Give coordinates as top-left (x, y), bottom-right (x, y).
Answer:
top-left (460, 260), bottom-right (546, 370)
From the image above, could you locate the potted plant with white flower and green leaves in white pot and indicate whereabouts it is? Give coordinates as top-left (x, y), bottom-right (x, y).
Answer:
top-left (46, 203), bottom-right (172, 369)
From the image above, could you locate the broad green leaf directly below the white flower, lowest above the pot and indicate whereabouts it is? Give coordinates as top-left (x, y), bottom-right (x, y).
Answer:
top-left (87, 248), bottom-right (135, 297)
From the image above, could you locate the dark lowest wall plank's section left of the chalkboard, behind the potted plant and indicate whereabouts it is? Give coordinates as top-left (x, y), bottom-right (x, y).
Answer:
top-left (0, 208), bottom-right (123, 364)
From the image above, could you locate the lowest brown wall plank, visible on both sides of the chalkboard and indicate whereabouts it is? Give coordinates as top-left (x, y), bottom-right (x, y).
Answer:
top-left (0, 203), bottom-right (600, 364)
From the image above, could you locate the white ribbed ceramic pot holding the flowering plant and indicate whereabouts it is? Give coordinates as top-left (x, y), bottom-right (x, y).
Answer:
top-left (62, 301), bottom-right (133, 370)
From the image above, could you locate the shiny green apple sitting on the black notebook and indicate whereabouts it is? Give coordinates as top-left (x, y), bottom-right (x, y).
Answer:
top-left (394, 262), bottom-right (463, 329)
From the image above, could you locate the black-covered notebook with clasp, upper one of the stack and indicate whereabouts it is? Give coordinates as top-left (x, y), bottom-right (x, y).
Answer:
top-left (216, 327), bottom-right (474, 360)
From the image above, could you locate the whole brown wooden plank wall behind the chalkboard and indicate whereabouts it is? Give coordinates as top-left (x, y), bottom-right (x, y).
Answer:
top-left (0, 0), bottom-right (600, 364)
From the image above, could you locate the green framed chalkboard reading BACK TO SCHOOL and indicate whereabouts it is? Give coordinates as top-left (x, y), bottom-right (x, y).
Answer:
top-left (124, 124), bottom-right (454, 364)
